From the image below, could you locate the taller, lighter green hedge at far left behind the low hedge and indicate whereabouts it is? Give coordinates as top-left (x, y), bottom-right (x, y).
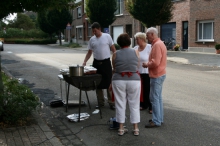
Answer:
top-left (0, 28), bottom-right (49, 38)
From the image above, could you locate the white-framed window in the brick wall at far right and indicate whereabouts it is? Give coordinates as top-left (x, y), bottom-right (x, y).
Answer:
top-left (197, 21), bottom-right (214, 41)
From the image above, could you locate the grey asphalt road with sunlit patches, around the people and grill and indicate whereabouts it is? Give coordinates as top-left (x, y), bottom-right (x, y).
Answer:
top-left (1, 44), bottom-right (220, 146)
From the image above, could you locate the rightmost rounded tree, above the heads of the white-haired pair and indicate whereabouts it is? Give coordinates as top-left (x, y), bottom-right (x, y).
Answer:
top-left (126, 0), bottom-right (173, 27)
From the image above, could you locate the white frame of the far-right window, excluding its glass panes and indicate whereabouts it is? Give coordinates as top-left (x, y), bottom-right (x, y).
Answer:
top-left (197, 20), bottom-right (214, 42)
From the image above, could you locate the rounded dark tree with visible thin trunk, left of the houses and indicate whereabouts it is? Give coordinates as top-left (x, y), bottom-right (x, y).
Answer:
top-left (47, 9), bottom-right (72, 45)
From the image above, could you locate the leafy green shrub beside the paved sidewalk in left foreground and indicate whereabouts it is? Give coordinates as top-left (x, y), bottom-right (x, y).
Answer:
top-left (0, 73), bottom-right (40, 125)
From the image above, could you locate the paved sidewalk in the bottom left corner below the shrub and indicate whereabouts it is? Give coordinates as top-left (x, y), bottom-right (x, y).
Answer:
top-left (0, 112), bottom-right (62, 146)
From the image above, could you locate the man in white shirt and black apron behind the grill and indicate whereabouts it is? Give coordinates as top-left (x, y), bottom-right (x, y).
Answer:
top-left (83, 22), bottom-right (116, 109)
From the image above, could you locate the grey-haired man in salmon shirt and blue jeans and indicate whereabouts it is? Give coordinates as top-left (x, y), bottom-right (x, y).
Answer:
top-left (143, 27), bottom-right (167, 128)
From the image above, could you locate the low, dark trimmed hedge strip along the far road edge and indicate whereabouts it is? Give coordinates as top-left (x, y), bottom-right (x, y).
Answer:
top-left (4, 38), bottom-right (57, 44)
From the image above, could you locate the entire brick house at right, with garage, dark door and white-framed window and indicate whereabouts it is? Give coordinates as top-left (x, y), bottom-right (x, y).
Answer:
top-left (160, 0), bottom-right (220, 53)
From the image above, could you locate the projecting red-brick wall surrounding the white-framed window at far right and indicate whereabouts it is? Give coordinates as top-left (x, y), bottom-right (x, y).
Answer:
top-left (189, 0), bottom-right (220, 51)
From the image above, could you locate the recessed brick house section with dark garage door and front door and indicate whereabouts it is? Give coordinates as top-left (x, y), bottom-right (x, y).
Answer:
top-left (159, 0), bottom-right (190, 49)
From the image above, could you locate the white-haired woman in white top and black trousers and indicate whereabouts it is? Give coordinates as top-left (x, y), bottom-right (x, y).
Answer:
top-left (134, 32), bottom-right (152, 114)
